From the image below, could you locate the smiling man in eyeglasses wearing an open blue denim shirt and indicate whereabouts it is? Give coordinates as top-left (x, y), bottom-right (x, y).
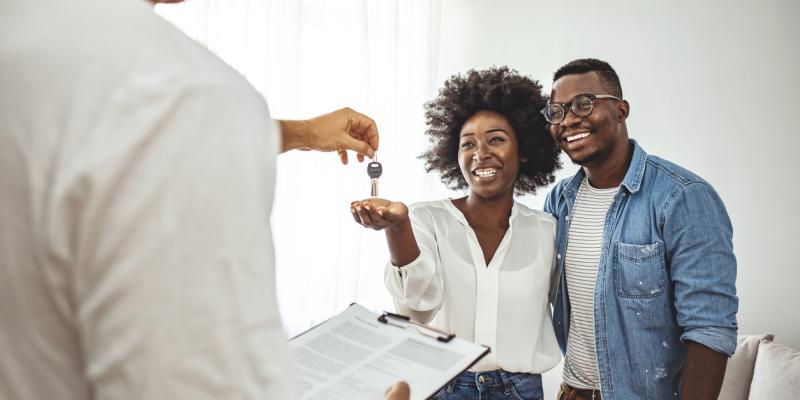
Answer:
top-left (542, 59), bottom-right (738, 400)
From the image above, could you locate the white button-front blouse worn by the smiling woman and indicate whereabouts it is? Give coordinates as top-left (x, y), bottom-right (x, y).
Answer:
top-left (385, 199), bottom-right (561, 373)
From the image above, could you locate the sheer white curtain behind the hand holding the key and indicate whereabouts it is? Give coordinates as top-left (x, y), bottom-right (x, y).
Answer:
top-left (157, 0), bottom-right (451, 335)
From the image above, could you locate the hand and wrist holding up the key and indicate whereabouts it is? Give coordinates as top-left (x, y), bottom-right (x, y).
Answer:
top-left (280, 107), bottom-right (378, 164)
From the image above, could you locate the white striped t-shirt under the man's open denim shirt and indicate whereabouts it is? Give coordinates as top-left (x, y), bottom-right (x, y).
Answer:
top-left (564, 178), bottom-right (619, 389)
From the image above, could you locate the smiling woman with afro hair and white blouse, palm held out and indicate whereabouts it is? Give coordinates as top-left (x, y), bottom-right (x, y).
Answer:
top-left (351, 67), bottom-right (560, 399)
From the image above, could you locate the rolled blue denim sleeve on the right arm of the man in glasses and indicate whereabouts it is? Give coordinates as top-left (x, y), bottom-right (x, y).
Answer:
top-left (664, 182), bottom-right (739, 356)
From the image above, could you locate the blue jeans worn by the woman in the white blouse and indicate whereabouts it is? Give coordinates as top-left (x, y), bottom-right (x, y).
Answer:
top-left (433, 369), bottom-right (544, 400)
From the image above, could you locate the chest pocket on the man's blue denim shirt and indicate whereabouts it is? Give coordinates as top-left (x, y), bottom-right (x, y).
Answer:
top-left (614, 241), bottom-right (667, 299)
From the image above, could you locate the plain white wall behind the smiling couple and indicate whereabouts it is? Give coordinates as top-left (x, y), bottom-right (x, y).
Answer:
top-left (438, 0), bottom-right (800, 391)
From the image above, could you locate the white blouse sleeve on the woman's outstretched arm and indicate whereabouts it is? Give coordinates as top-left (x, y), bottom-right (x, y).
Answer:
top-left (384, 205), bottom-right (444, 322)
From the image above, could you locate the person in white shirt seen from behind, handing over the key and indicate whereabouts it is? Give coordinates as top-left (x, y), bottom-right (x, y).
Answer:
top-left (0, 0), bottom-right (408, 400)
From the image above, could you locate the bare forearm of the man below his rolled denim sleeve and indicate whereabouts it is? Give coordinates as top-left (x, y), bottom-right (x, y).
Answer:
top-left (681, 342), bottom-right (728, 400)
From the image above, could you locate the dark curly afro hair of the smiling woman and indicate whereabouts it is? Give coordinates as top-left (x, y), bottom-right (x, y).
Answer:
top-left (420, 67), bottom-right (561, 194)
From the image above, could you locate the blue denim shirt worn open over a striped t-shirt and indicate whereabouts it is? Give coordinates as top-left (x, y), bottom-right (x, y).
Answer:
top-left (544, 140), bottom-right (739, 400)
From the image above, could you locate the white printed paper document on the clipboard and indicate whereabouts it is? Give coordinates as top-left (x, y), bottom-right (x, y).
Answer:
top-left (290, 304), bottom-right (489, 400)
